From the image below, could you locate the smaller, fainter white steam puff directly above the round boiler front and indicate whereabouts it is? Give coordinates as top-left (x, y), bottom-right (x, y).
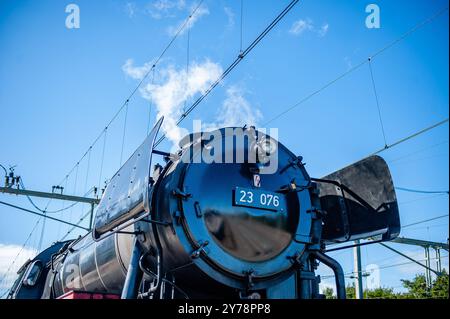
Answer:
top-left (203, 85), bottom-right (262, 130)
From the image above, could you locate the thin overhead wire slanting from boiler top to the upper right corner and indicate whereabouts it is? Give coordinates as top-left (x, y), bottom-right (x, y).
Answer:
top-left (263, 7), bottom-right (448, 127)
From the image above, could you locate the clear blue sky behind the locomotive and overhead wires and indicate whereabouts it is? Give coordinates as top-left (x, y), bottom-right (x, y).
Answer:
top-left (0, 0), bottom-right (449, 296)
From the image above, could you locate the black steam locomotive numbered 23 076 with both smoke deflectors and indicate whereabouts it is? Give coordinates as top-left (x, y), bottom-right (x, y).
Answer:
top-left (8, 118), bottom-right (400, 299)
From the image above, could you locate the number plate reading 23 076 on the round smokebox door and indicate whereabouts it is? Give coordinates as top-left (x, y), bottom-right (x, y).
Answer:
top-left (234, 187), bottom-right (285, 211)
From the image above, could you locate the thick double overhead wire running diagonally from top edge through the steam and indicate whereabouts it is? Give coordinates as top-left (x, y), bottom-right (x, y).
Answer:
top-left (154, 0), bottom-right (299, 147)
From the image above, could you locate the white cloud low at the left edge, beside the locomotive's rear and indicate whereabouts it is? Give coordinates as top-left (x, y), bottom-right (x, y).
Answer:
top-left (0, 244), bottom-right (36, 295)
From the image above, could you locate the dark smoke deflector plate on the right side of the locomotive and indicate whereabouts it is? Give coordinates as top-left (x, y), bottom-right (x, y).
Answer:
top-left (316, 156), bottom-right (400, 243)
